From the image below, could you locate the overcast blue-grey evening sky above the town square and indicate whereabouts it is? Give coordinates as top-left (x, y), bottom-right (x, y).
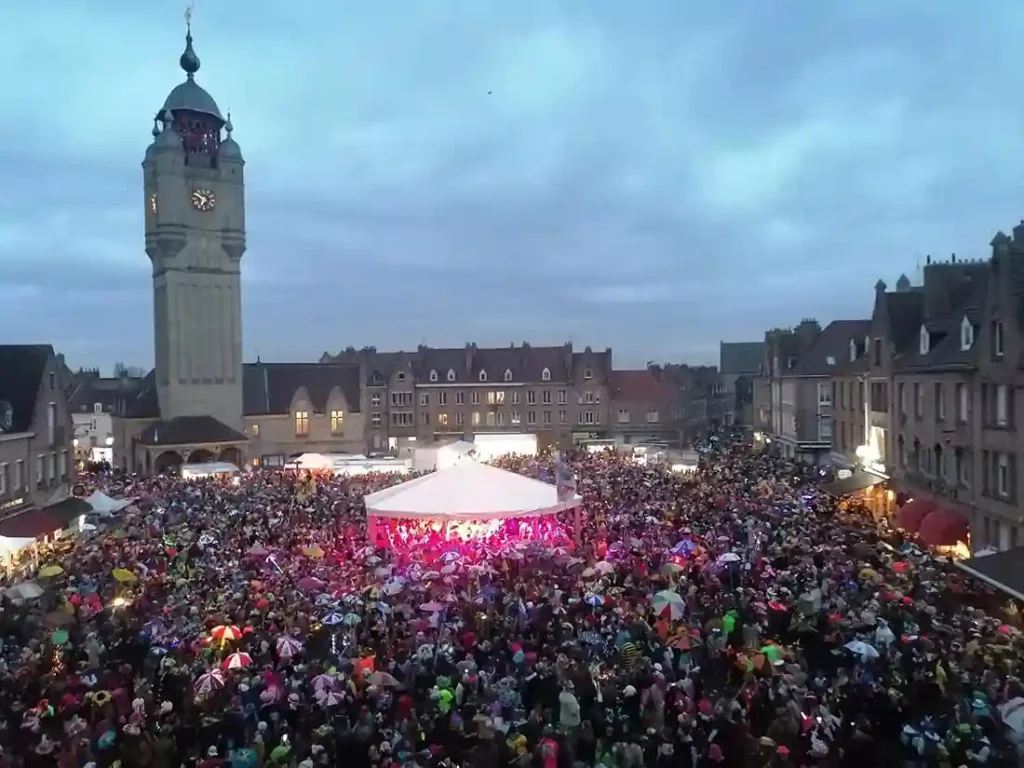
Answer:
top-left (0, 0), bottom-right (1024, 369)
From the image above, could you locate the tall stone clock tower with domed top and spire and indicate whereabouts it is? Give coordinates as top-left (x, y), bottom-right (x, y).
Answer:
top-left (142, 27), bottom-right (246, 430)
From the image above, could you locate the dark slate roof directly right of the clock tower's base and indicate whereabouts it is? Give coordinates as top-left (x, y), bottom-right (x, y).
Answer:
top-left (242, 362), bottom-right (361, 416)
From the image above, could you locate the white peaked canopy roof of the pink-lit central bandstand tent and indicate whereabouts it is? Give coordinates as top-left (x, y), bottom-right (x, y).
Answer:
top-left (366, 461), bottom-right (583, 520)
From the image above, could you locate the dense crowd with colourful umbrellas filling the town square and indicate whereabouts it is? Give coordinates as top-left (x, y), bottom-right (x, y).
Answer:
top-left (0, 446), bottom-right (1024, 768)
